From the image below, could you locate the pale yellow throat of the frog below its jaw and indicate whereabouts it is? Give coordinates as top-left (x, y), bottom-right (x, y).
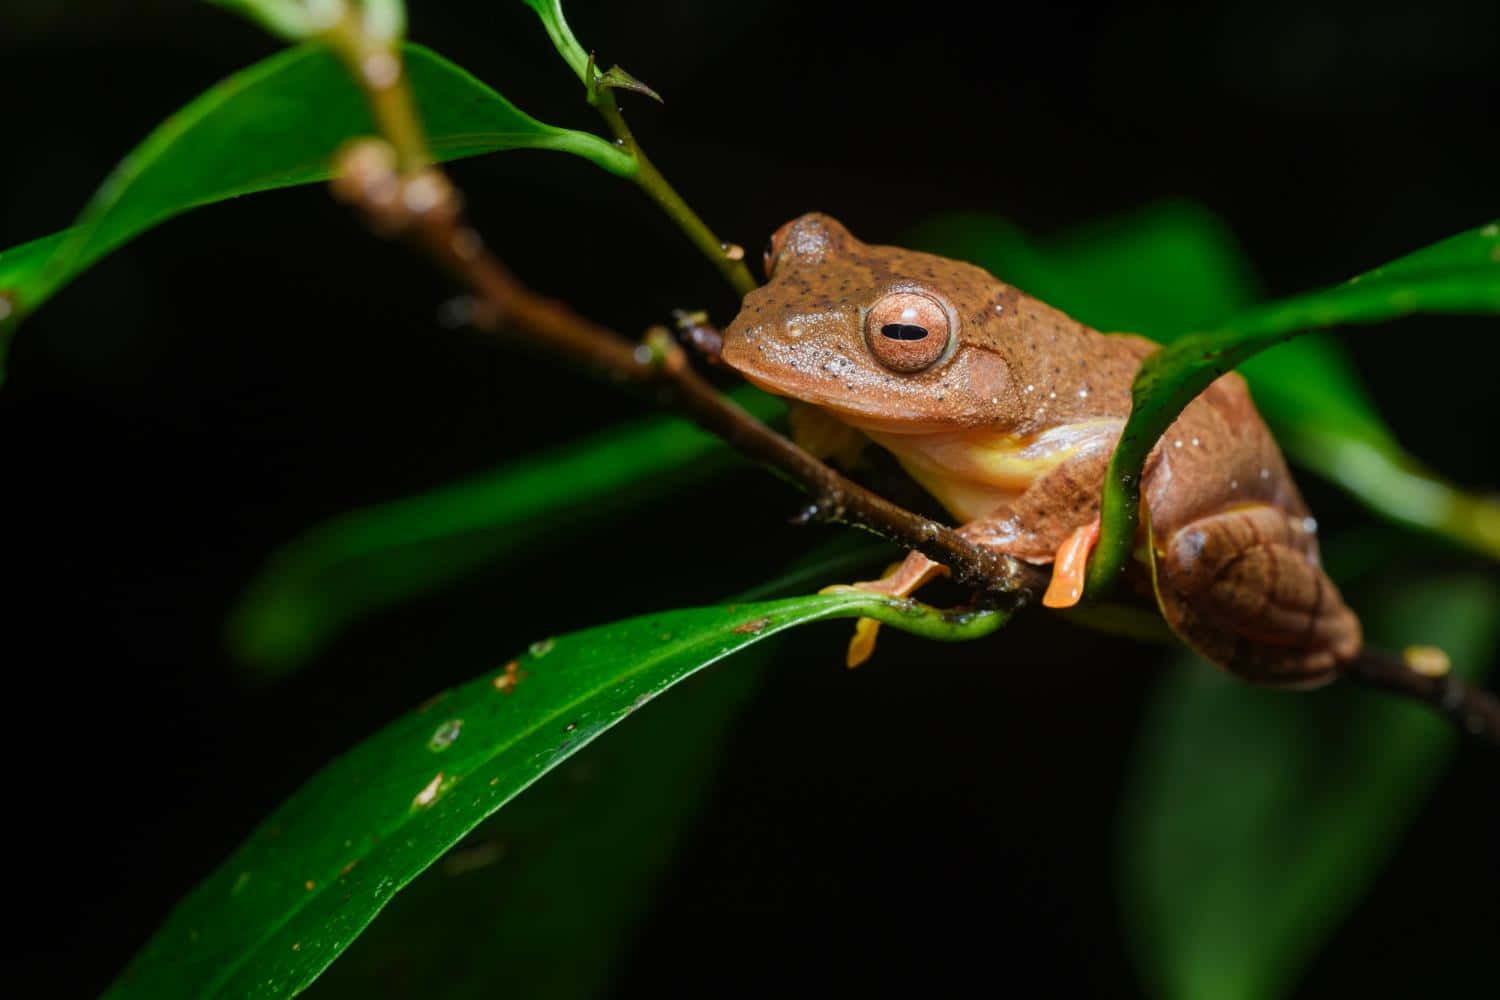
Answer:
top-left (863, 418), bottom-right (1125, 522)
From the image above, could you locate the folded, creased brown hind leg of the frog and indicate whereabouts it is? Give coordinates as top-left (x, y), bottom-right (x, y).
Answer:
top-left (1157, 507), bottom-right (1361, 687)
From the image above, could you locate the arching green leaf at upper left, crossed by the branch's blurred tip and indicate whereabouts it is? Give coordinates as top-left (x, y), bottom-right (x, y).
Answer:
top-left (0, 36), bottom-right (636, 371)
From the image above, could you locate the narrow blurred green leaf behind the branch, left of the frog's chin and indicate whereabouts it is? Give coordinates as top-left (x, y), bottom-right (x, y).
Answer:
top-left (227, 391), bottom-right (782, 670)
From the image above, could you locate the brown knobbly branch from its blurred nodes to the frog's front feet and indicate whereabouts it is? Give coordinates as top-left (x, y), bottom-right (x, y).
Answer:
top-left (333, 139), bottom-right (1047, 606)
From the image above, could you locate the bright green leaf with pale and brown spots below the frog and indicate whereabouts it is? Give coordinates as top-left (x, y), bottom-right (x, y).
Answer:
top-left (107, 591), bottom-right (1005, 999)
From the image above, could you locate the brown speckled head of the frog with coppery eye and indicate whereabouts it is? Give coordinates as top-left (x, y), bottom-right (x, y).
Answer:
top-left (723, 213), bottom-right (1019, 433)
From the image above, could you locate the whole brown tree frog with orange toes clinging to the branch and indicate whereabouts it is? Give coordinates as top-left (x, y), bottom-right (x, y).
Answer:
top-left (720, 213), bottom-right (1362, 688)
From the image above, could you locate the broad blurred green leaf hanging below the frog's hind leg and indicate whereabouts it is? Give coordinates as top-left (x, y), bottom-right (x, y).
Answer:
top-left (1121, 576), bottom-right (1500, 1000)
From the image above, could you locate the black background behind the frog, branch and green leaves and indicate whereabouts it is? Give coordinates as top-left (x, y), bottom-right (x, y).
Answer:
top-left (0, 0), bottom-right (1500, 996)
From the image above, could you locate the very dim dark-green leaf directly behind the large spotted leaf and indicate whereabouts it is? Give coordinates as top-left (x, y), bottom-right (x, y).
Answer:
top-left (309, 532), bottom-right (899, 1000)
